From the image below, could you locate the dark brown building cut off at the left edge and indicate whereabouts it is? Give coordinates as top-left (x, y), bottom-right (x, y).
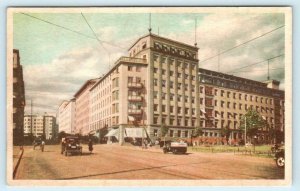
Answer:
top-left (13, 49), bottom-right (25, 145)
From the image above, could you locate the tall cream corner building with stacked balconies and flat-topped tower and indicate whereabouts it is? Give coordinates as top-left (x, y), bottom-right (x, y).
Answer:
top-left (90, 34), bottom-right (200, 142)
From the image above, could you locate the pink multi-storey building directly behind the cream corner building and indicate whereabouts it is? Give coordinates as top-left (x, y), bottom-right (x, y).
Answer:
top-left (74, 78), bottom-right (99, 135)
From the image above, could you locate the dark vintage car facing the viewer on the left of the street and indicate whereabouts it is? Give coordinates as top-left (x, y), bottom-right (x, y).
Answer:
top-left (63, 136), bottom-right (82, 156)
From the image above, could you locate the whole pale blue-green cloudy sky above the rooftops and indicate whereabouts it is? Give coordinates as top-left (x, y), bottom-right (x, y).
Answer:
top-left (13, 12), bottom-right (285, 114)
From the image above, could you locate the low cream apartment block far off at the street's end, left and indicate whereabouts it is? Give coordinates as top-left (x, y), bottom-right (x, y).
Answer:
top-left (24, 114), bottom-right (56, 140)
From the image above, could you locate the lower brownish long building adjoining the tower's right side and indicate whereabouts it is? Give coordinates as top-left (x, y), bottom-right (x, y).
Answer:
top-left (199, 69), bottom-right (284, 141)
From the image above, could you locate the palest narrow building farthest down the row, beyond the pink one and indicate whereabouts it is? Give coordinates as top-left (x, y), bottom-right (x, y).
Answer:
top-left (58, 98), bottom-right (75, 134)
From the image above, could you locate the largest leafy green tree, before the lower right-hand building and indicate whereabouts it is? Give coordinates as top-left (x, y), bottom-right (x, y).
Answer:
top-left (240, 109), bottom-right (267, 142)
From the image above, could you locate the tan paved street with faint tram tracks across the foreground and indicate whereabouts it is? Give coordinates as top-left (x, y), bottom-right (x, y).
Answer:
top-left (16, 145), bottom-right (284, 179)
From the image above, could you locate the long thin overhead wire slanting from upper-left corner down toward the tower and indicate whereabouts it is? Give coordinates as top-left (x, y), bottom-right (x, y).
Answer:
top-left (21, 13), bottom-right (126, 50)
